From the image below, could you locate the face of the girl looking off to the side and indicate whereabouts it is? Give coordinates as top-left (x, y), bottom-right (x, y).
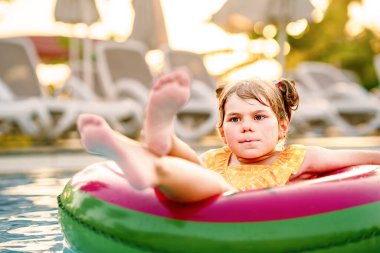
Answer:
top-left (219, 94), bottom-right (287, 161)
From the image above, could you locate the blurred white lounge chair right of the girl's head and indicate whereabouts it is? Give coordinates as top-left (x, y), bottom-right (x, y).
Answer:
top-left (294, 62), bottom-right (380, 134)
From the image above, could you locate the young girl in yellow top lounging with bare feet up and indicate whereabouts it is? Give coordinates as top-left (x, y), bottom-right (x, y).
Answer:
top-left (77, 70), bottom-right (380, 202)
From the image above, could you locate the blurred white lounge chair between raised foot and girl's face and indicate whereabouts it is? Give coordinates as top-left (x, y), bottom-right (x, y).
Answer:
top-left (163, 48), bottom-right (219, 141)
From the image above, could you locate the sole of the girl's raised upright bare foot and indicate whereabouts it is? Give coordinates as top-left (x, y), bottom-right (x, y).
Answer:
top-left (144, 69), bottom-right (191, 156)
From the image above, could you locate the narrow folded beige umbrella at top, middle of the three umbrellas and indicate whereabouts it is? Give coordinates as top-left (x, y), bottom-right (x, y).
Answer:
top-left (130, 0), bottom-right (168, 49)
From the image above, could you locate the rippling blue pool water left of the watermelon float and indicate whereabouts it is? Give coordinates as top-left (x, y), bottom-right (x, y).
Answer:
top-left (0, 170), bottom-right (73, 253)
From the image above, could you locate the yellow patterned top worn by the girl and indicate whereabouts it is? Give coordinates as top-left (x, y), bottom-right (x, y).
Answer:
top-left (202, 145), bottom-right (306, 191)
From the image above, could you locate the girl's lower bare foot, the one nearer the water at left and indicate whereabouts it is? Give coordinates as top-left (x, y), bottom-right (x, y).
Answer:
top-left (77, 114), bottom-right (156, 190)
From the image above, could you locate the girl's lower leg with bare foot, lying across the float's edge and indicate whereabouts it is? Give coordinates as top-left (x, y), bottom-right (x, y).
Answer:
top-left (78, 114), bottom-right (233, 202)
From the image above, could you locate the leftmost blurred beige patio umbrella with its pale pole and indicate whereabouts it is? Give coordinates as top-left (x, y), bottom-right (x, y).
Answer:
top-left (54, 0), bottom-right (100, 88)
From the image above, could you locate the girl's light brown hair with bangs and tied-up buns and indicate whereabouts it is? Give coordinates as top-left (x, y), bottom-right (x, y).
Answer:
top-left (216, 79), bottom-right (299, 128)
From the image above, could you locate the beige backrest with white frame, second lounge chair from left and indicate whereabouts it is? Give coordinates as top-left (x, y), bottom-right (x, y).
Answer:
top-left (95, 40), bottom-right (153, 106)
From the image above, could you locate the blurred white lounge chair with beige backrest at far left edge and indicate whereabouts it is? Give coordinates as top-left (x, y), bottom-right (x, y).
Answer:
top-left (0, 38), bottom-right (142, 139)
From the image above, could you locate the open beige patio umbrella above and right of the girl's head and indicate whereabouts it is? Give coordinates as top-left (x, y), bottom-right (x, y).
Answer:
top-left (211, 0), bottom-right (313, 67)
